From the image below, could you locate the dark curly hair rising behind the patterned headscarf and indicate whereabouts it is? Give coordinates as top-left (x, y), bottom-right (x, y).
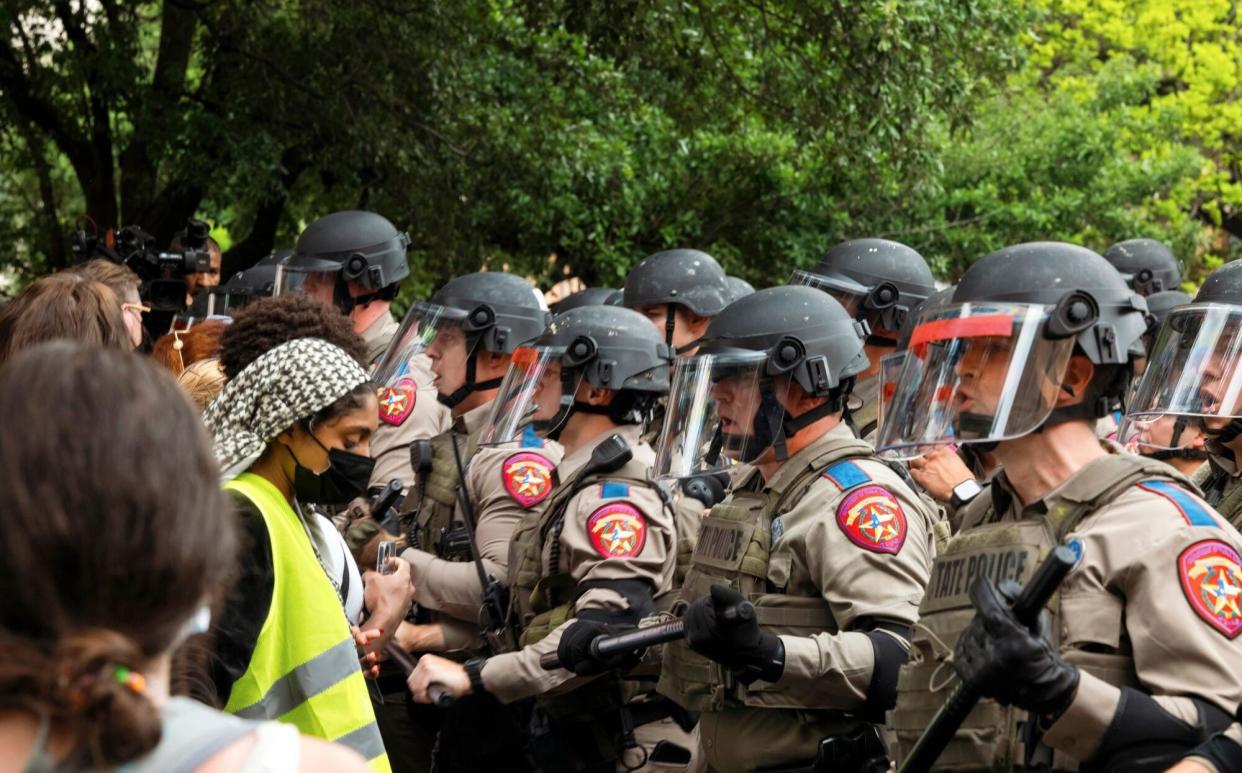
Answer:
top-left (220, 292), bottom-right (368, 379)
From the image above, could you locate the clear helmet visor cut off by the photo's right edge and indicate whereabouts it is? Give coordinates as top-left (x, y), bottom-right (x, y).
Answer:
top-left (1126, 303), bottom-right (1242, 426)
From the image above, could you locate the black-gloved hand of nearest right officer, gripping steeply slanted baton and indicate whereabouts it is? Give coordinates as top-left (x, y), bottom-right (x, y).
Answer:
top-left (953, 575), bottom-right (1078, 716)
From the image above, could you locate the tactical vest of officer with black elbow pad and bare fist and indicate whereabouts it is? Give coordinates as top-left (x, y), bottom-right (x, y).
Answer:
top-left (509, 459), bottom-right (668, 646)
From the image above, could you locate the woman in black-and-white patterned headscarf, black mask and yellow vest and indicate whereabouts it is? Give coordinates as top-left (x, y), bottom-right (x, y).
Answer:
top-left (204, 338), bottom-right (397, 771)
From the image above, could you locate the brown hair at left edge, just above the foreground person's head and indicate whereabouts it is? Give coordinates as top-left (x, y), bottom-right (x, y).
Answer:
top-left (0, 273), bottom-right (134, 365)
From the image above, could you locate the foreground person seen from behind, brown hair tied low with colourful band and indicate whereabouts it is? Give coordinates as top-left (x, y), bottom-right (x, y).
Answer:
top-left (0, 342), bottom-right (365, 773)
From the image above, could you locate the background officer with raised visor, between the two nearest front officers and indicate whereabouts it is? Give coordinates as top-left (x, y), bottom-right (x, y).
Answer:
top-left (789, 239), bottom-right (935, 440)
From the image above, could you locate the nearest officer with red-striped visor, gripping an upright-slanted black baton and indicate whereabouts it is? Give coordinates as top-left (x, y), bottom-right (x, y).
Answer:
top-left (878, 242), bottom-right (1242, 771)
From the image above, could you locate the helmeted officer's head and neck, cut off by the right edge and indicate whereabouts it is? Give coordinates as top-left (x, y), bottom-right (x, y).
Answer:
top-left (1126, 261), bottom-right (1242, 528)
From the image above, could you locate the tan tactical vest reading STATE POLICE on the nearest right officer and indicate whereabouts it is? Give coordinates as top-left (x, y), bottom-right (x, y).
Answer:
top-left (888, 454), bottom-right (1194, 771)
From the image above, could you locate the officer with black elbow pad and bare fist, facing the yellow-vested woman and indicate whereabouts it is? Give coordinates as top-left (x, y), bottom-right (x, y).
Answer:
top-left (409, 306), bottom-right (674, 771)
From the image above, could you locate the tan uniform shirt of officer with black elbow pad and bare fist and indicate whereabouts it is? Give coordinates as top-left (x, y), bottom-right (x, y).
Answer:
top-left (481, 426), bottom-right (677, 702)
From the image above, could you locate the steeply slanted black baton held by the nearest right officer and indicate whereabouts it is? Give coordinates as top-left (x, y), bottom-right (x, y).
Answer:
top-left (899, 546), bottom-right (1078, 773)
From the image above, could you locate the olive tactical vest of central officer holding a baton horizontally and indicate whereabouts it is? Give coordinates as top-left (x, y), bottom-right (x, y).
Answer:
top-left (660, 439), bottom-right (881, 723)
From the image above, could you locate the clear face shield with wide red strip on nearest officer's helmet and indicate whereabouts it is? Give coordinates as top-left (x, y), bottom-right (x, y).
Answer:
top-left (876, 303), bottom-right (1074, 457)
